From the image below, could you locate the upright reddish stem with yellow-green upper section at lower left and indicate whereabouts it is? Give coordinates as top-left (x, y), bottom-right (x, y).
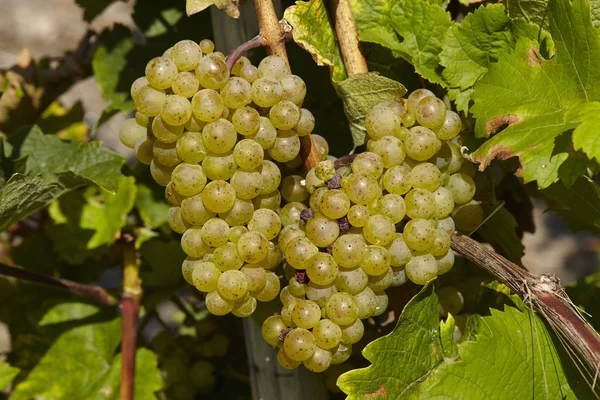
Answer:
top-left (119, 235), bottom-right (142, 400)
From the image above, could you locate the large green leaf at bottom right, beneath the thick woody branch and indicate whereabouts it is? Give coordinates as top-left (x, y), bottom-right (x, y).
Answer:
top-left (338, 283), bottom-right (576, 400)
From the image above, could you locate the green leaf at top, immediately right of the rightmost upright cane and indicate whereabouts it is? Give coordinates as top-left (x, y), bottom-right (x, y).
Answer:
top-left (351, 0), bottom-right (452, 86)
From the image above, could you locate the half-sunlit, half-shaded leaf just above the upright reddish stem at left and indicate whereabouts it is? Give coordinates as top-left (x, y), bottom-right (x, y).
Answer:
top-left (47, 177), bottom-right (136, 264)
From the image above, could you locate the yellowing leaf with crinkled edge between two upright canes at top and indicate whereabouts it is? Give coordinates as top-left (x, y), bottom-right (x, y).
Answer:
top-left (283, 0), bottom-right (346, 81)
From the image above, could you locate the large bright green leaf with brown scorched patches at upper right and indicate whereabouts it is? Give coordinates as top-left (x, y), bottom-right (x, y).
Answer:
top-left (472, 0), bottom-right (600, 188)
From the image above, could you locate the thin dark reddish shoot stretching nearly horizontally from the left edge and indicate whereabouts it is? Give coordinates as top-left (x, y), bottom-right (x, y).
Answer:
top-left (0, 263), bottom-right (119, 306)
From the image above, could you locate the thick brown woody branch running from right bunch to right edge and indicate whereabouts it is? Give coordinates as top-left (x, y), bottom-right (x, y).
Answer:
top-left (452, 233), bottom-right (600, 390)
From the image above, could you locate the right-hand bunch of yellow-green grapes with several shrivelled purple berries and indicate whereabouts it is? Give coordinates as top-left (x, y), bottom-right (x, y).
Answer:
top-left (262, 89), bottom-right (481, 372)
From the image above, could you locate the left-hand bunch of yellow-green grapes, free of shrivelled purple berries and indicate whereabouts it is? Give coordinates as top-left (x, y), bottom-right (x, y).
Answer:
top-left (119, 40), bottom-right (327, 317)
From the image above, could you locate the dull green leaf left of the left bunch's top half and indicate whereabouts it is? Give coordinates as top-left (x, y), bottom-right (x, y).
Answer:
top-left (11, 126), bottom-right (125, 192)
